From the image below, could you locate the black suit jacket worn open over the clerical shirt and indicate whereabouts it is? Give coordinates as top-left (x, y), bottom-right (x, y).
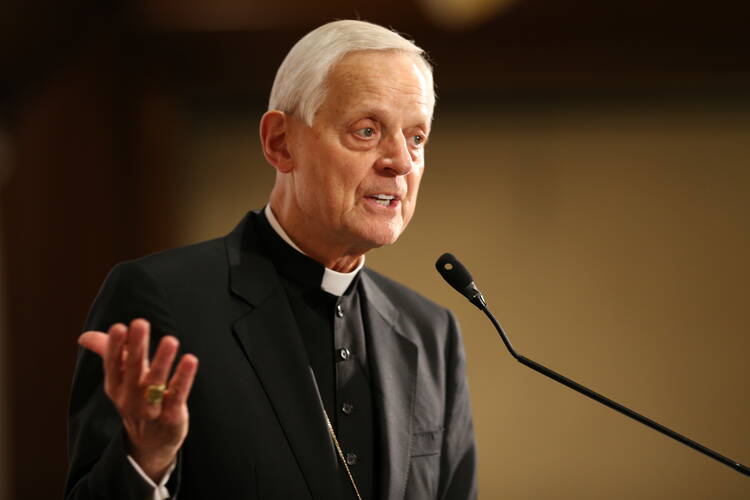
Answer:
top-left (66, 212), bottom-right (476, 500)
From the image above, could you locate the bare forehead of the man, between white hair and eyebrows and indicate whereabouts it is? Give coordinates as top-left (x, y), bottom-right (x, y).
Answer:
top-left (321, 51), bottom-right (434, 121)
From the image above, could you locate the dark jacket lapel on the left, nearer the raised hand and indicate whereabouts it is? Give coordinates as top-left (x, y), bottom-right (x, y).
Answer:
top-left (227, 215), bottom-right (338, 500)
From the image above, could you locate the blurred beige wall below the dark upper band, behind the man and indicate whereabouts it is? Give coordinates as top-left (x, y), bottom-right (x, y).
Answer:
top-left (166, 102), bottom-right (750, 500)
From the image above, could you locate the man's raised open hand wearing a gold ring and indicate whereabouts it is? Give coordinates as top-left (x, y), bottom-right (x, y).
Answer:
top-left (78, 319), bottom-right (198, 482)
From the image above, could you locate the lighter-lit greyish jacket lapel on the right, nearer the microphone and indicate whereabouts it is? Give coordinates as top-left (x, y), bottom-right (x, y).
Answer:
top-left (362, 270), bottom-right (418, 500)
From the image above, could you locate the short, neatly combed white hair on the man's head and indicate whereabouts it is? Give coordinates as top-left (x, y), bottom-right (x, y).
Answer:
top-left (268, 20), bottom-right (435, 126)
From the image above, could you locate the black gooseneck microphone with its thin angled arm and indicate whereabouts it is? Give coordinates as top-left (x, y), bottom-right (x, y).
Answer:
top-left (435, 253), bottom-right (750, 476)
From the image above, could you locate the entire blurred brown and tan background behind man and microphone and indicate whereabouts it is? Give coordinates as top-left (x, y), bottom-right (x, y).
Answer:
top-left (0, 0), bottom-right (750, 500)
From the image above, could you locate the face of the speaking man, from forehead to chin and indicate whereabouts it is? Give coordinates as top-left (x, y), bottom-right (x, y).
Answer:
top-left (287, 51), bottom-right (434, 253)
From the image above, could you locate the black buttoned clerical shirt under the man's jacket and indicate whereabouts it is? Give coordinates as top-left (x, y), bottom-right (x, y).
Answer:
top-left (259, 208), bottom-right (377, 500)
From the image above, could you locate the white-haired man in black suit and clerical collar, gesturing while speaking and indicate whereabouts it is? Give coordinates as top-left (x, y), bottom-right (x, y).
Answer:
top-left (66, 21), bottom-right (476, 500)
